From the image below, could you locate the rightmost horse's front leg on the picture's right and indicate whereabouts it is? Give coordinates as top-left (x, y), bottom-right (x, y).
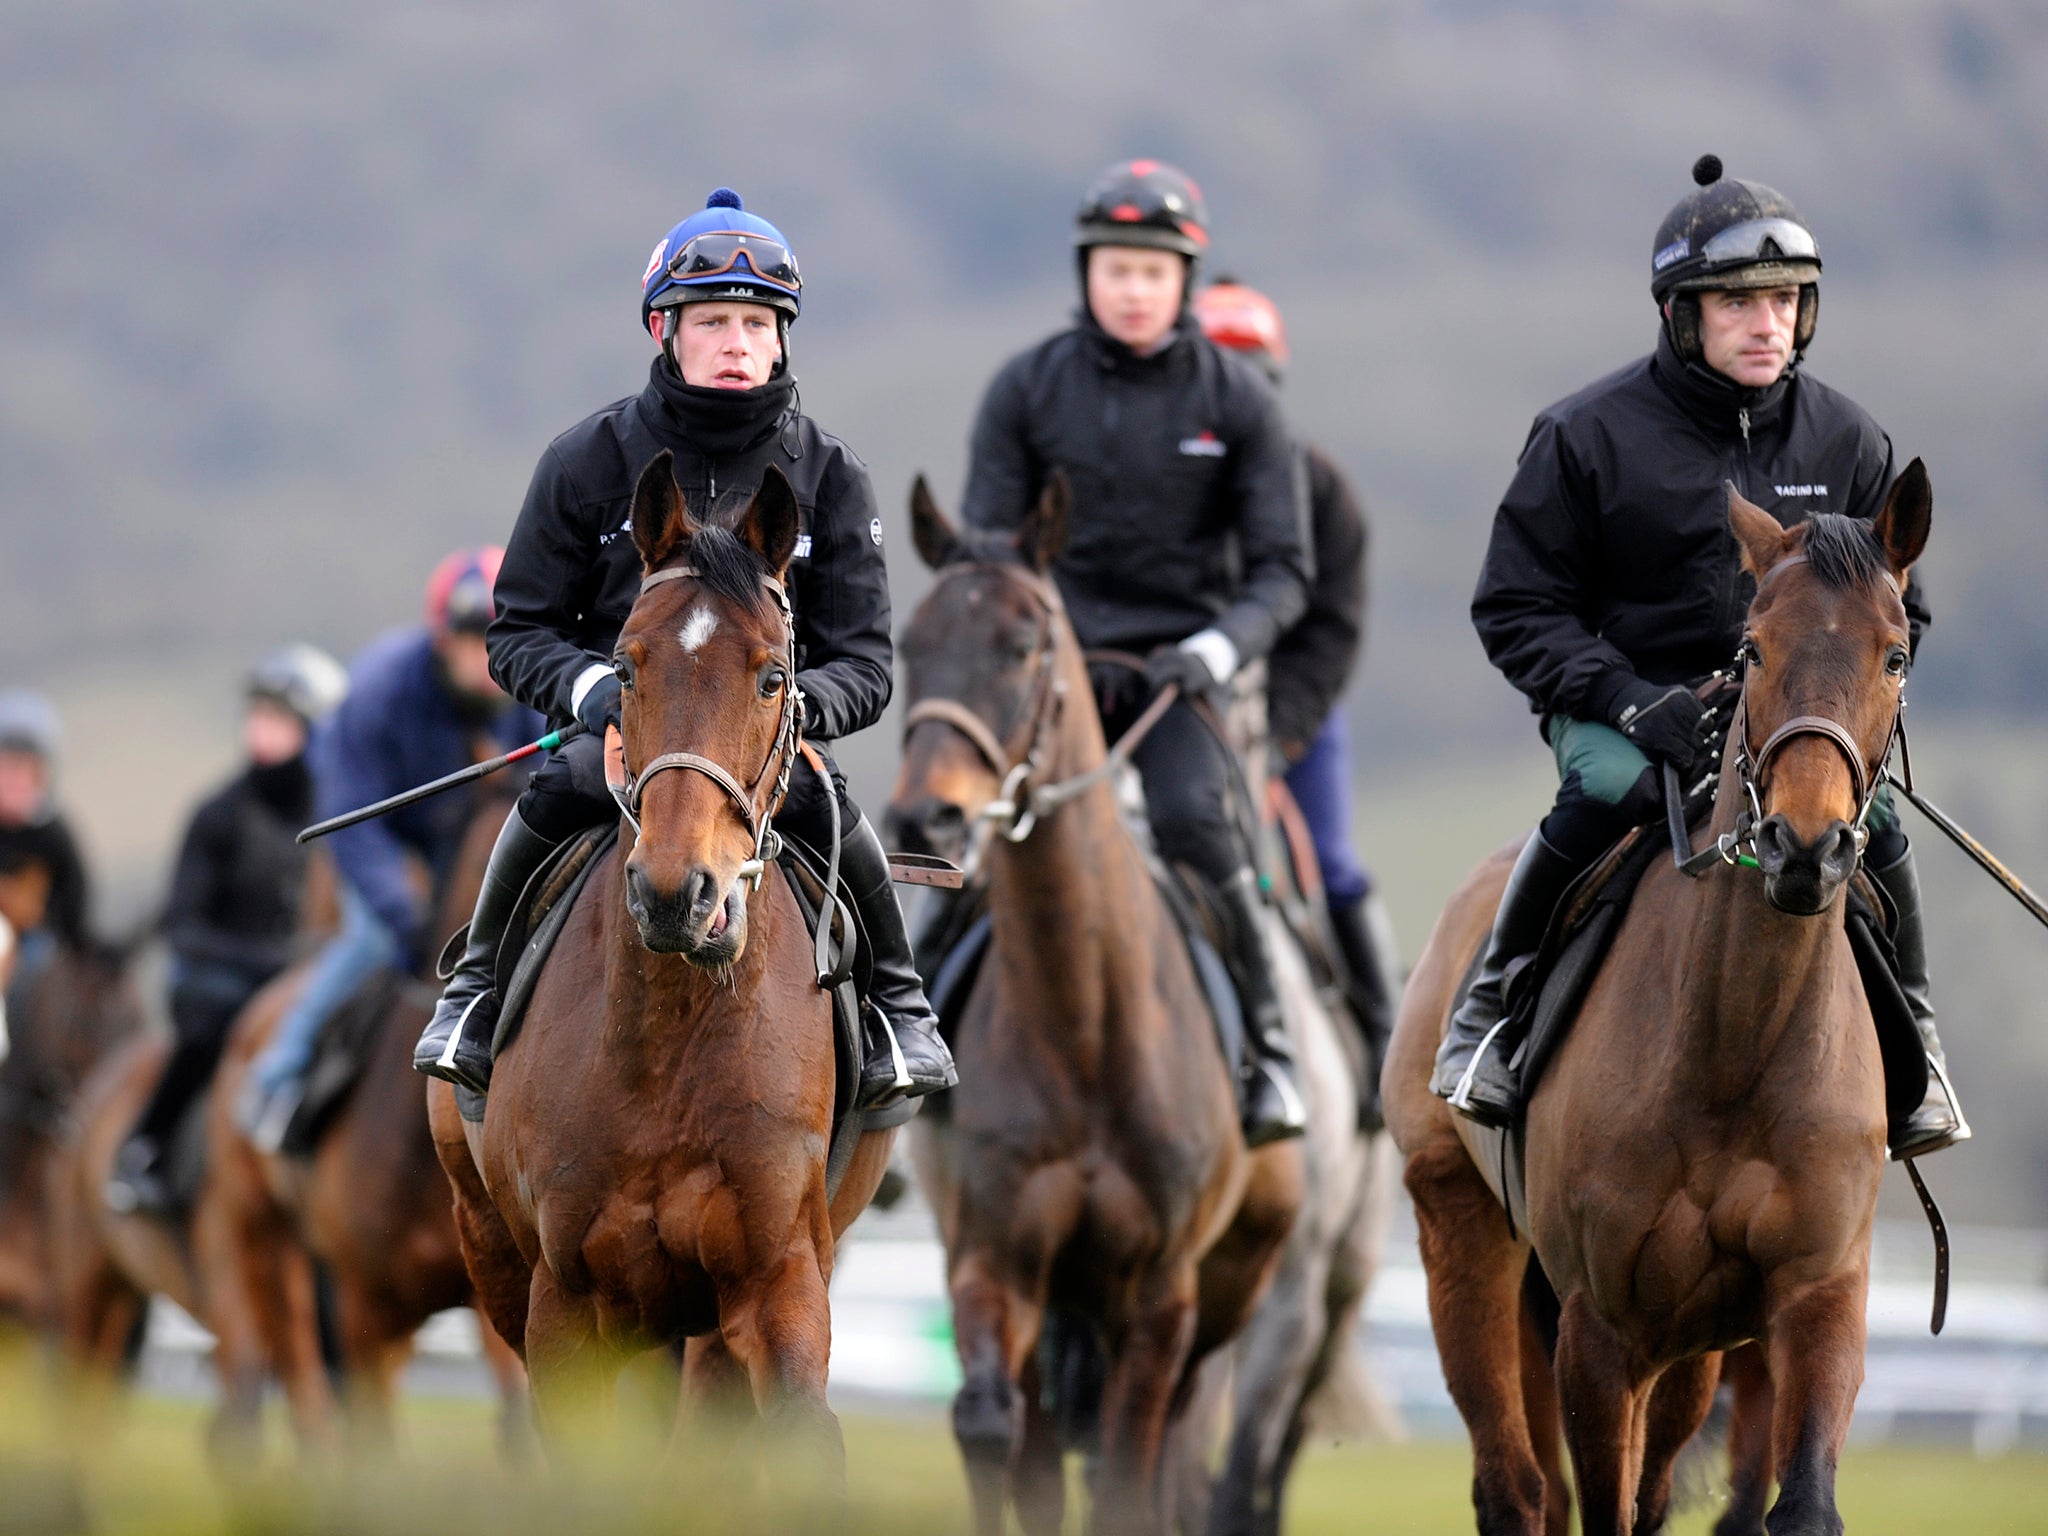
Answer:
top-left (1763, 1266), bottom-right (1870, 1536)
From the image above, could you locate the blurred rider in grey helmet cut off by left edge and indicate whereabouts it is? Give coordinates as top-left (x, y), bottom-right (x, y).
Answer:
top-left (0, 688), bottom-right (88, 989)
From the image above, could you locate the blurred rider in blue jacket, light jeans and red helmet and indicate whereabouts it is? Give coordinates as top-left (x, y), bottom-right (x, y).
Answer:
top-left (236, 547), bottom-right (541, 1151)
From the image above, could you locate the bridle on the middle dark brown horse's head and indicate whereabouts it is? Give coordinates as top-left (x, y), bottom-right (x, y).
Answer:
top-left (903, 561), bottom-right (1180, 842)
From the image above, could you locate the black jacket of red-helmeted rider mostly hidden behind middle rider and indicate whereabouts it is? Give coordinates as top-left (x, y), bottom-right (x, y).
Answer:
top-left (1266, 446), bottom-right (1368, 762)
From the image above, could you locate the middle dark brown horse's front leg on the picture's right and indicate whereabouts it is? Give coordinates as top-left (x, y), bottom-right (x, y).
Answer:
top-left (1094, 1262), bottom-right (1198, 1534)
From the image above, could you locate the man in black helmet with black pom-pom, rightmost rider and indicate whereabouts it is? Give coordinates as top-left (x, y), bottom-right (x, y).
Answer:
top-left (1432, 156), bottom-right (1970, 1157)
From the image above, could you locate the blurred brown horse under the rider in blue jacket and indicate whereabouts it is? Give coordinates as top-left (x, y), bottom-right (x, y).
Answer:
top-left (203, 776), bottom-right (526, 1448)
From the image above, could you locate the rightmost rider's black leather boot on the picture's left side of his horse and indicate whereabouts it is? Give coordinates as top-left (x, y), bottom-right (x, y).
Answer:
top-left (1430, 829), bottom-right (1585, 1126)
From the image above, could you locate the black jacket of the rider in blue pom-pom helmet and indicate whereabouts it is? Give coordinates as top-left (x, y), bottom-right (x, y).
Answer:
top-left (487, 356), bottom-right (893, 741)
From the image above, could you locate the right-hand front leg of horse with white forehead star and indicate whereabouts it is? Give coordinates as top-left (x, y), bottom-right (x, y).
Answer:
top-left (719, 1243), bottom-right (846, 1499)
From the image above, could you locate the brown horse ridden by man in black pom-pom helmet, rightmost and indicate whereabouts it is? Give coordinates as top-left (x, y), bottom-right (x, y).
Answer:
top-left (1384, 473), bottom-right (1931, 1536)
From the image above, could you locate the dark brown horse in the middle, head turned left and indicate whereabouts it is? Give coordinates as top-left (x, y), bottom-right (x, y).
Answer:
top-left (889, 481), bottom-right (1303, 1536)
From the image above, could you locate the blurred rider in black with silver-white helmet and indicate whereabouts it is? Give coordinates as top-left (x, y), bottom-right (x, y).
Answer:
top-left (106, 645), bottom-right (348, 1214)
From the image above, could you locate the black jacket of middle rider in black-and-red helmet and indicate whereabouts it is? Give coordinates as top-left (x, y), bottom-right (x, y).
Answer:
top-left (963, 317), bottom-right (1309, 662)
